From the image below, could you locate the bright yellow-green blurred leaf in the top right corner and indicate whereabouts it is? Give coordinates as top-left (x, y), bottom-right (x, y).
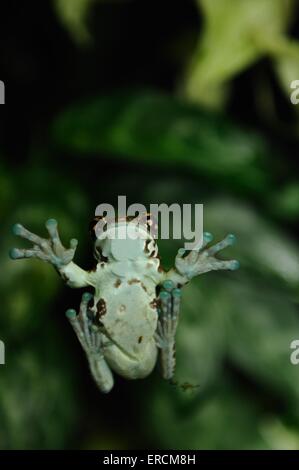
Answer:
top-left (184, 0), bottom-right (299, 108)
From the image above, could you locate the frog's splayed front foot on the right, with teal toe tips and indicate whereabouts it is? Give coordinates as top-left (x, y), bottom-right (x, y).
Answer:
top-left (175, 232), bottom-right (240, 280)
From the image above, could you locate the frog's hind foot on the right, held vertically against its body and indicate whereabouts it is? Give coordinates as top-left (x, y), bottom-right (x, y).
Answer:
top-left (155, 280), bottom-right (181, 379)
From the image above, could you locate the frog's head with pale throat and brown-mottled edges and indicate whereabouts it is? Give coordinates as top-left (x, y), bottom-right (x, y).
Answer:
top-left (90, 214), bottom-right (158, 261)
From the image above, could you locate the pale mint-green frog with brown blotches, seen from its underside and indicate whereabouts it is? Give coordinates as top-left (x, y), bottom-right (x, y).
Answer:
top-left (10, 216), bottom-right (239, 393)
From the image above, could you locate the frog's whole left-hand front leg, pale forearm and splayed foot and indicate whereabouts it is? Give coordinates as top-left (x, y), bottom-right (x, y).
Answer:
top-left (10, 219), bottom-right (92, 287)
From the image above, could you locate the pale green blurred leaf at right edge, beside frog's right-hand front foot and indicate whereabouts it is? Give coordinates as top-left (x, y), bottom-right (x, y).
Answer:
top-left (205, 197), bottom-right (299, 288)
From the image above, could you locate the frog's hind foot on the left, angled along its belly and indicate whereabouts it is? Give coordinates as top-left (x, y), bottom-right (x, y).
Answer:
top-left (66, 292), bottom-right (114, 393)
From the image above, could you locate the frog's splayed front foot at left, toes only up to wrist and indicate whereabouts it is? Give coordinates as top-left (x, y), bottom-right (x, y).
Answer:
top-left (10, 219), bottom-right (78, 269)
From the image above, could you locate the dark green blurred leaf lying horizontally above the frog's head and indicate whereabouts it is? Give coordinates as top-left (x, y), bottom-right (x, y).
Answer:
top-left (53, 92), bottom-right (275, 193)
